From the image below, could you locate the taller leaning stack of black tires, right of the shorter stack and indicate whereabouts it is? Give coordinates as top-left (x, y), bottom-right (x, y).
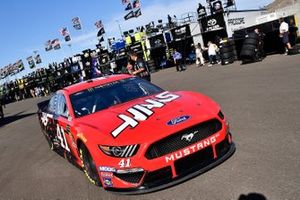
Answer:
top-left (240, 33), bottom-right (259, 63)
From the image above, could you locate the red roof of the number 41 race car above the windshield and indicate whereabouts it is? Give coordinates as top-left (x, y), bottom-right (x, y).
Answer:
top-left (62, 74), bottom-right (132, 95)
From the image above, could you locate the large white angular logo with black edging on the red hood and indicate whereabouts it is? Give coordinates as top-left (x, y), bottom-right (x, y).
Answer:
top-left (111, 92), bottom-right (179, 137)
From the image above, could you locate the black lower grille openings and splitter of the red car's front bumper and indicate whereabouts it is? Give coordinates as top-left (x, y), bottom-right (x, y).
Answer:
top-left (105, 134), bottom-right (236, 194)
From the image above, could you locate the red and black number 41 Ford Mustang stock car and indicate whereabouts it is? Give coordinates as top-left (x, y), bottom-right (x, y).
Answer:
top-left (38, 75), bottom-right (235, 194)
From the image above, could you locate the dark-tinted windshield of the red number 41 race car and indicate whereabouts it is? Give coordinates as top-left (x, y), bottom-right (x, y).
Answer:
top-left (70, 77), bottom-right (163, 117)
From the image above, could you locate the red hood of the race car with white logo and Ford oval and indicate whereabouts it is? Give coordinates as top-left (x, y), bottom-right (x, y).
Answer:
top-left (77, 92), bottom-right (220, 145)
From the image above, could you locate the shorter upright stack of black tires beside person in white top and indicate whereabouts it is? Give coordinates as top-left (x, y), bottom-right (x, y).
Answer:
top-left (219, 40), bottom-right (237, 65)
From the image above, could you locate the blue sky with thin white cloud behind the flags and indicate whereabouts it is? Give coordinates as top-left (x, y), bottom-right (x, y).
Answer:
top-left (0, 0), bottom-right (272, 80)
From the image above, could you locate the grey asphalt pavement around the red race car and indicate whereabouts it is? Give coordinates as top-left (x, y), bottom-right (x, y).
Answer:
top-left (0, 55), bottom-right (300, 200)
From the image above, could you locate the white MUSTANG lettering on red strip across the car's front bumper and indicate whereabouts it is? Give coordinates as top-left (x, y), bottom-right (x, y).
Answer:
top-left (165, 135), bottom-right (218, 163)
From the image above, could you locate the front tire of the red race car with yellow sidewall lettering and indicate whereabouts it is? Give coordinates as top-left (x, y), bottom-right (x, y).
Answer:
top-left (79, 144), bottom-right (102, 186)
